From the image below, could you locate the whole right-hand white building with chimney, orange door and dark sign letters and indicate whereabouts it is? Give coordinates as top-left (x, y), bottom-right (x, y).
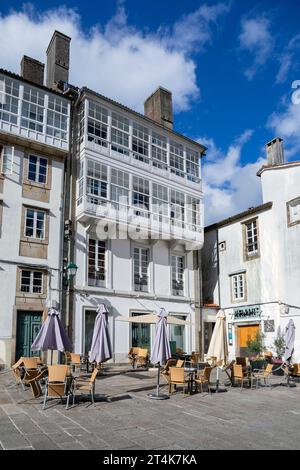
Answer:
top-left (202, 138), bottom-right (300, 361)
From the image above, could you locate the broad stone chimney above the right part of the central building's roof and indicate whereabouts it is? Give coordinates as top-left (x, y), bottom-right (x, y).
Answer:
top-left (144, 87), bottom-right (173, 129)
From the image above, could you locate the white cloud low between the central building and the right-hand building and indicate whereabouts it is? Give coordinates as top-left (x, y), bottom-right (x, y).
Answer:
top-left (198, 130), bottom-right (265, 225)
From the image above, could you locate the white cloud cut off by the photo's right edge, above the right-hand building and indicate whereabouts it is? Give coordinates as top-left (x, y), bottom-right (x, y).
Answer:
top-left (267, 98), bottom-right (300, 160)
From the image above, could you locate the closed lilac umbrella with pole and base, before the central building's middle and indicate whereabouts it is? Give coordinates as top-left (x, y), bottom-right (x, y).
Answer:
top-left (148, 308), bottom-right (172, 400)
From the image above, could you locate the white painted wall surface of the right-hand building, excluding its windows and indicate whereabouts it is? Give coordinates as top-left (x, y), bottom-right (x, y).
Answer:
top-left (203, 165), bottom-right (300, 361)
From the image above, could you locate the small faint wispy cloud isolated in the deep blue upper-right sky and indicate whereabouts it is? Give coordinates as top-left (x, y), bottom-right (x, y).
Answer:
top-left (239, 16), bottom-right (274, 80)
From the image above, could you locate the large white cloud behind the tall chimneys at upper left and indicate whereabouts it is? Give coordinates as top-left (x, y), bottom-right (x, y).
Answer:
top-left (0, 3), bottom-right (230, 111)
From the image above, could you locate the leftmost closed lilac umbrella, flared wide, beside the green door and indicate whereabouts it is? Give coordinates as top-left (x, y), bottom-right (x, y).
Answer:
top-left (31, 308), bottom-right (73, 364)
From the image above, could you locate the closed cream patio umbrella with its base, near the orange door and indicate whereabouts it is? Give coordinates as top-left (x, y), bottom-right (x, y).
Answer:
top-left (207, 309), bottom-right (228, 393)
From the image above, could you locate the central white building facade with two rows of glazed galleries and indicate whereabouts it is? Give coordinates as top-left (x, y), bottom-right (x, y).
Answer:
top-left (73, 89), bottom-right (205, 362)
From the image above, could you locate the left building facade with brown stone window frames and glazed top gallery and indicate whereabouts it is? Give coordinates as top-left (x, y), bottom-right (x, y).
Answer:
top-left (0, 67), bottom-right (70, 367)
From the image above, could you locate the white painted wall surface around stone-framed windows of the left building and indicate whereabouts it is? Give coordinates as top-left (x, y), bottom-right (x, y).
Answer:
top-left (0, 147), bottom-right (64, 365)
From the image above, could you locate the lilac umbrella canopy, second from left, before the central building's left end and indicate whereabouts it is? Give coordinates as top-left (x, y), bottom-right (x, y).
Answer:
top-left (89, 304), bottom-right (112, 363)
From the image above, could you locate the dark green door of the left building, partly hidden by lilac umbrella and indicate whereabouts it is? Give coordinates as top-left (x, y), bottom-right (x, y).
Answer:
top-left (16, 311), bottom-right (43, 361)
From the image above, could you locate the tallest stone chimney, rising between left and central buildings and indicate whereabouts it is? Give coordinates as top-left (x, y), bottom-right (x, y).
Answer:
top-left (46, 31), bottom-right (71, 89)
